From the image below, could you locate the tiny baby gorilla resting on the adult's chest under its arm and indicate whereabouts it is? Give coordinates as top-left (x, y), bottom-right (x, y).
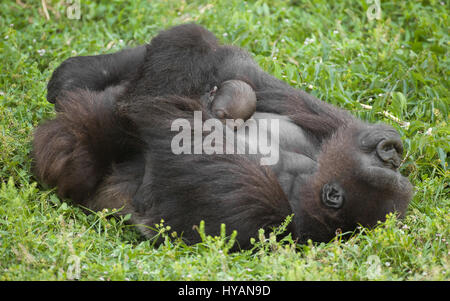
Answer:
top-left (202, 80), bottom-right (256, 128)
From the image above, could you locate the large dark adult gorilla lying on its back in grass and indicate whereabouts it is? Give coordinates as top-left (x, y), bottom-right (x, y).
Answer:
top-left (33, 24), bottom-right (412, 248)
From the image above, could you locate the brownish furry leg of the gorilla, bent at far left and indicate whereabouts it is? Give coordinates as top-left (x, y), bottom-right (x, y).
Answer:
top-left (33, 87), bottom-right (141, 204)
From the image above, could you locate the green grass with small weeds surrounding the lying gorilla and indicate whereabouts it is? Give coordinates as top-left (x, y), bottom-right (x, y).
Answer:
top-left (0, 0), bottom-right (450, 280)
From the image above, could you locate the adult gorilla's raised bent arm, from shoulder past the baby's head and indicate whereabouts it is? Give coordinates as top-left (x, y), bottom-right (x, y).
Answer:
top-left (135, 24), bottom-right (353, 143)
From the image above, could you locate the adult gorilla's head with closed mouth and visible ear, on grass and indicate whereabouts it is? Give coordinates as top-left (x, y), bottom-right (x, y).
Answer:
top-left (297, 123), bottom-right (412, 241)
